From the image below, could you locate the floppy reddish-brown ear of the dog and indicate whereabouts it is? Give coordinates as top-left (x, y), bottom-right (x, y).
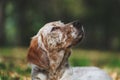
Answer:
top-left (27, 37), bottom-right (49, 69)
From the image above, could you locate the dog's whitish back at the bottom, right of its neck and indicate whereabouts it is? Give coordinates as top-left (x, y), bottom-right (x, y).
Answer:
top-left (60, 67), bottom-right (112, 80)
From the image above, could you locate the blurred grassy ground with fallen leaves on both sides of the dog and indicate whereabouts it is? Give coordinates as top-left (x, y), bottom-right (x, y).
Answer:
top-left (0, 48), bottom-right (120, 80)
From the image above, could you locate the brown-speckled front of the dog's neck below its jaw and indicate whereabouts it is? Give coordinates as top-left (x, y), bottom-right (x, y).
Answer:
top-left (48, 49), bottom-right (71, 80)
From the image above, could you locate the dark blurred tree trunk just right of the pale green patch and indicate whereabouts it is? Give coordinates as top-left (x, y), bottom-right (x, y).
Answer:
top-left (16, 0), bottom-right (30, 46)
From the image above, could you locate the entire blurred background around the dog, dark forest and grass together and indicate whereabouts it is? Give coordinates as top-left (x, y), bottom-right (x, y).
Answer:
top-left (0, 0), bottom-right (120, 80)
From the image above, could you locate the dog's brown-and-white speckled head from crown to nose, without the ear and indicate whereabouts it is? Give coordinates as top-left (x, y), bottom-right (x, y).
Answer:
top-left (38, 21), bottom-right (84, 50)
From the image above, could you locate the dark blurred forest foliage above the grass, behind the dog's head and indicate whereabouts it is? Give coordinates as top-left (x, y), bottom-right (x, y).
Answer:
top-left (0, 0), bottom-right (120, 50)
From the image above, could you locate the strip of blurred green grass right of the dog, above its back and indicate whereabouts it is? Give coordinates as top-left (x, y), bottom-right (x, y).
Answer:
top-left (70, 49), bottom-right (120, 68)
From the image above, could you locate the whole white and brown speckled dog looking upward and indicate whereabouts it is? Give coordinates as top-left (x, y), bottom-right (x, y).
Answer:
top-left (27, 21), bottom-right (112, 80)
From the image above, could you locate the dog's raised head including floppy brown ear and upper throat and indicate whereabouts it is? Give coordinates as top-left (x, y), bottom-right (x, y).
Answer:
top-left (27, 21), bottom-right (84, 69)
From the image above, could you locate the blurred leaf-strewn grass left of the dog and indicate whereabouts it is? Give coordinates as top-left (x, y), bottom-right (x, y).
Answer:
top-left (0, 48), bottom-right (31, 80)
